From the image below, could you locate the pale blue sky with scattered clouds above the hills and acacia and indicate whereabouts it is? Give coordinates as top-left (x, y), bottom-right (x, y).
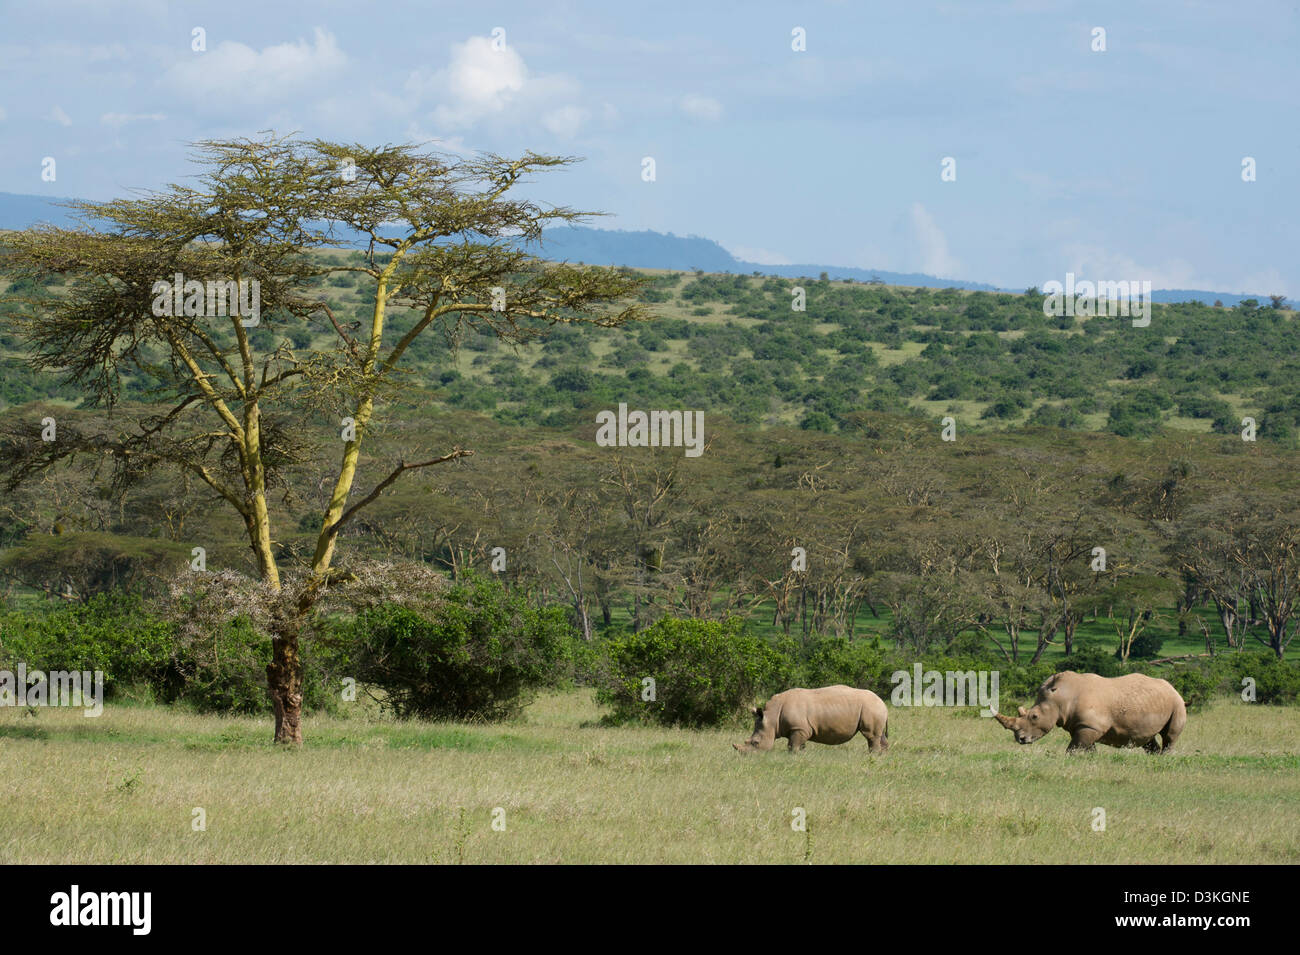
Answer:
top-left (0, 0), bottom-right (1300, 298)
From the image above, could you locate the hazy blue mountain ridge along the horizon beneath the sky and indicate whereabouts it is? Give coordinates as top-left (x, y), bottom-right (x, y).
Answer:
top-left (0, 192), bottom-right (1268, 307)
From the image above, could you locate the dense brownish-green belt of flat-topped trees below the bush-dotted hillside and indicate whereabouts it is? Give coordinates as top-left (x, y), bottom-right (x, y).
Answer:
top-left (0, 394), bottom-right (1300, 663)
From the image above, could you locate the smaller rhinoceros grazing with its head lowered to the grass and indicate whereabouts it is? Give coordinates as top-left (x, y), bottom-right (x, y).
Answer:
top-left (732, 686), bottom-right (889, 752)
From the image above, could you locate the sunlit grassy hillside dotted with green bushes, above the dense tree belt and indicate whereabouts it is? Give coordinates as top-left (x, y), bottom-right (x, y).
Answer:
top-left (0, 252), bottom-right (1300, 450)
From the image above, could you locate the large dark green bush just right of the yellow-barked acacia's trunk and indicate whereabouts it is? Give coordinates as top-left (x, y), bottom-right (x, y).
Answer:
top-left (341, 573), bottom-right (575, 720)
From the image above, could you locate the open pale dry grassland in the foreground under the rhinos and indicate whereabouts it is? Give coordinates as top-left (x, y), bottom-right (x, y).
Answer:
top-left (0, 690), bottom-right (1300, 864)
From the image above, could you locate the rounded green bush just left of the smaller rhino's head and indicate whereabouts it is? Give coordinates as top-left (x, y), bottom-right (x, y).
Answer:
top-left (597, 617), bottom-right (793, 726)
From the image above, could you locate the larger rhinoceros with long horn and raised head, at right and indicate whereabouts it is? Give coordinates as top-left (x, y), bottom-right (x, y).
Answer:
top-left (995, 670), bottom-right (1187, 752)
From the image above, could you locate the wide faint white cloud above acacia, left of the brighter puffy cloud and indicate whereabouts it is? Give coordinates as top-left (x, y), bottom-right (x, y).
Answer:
top-left (166, 27), bottom-right (347, 100)
